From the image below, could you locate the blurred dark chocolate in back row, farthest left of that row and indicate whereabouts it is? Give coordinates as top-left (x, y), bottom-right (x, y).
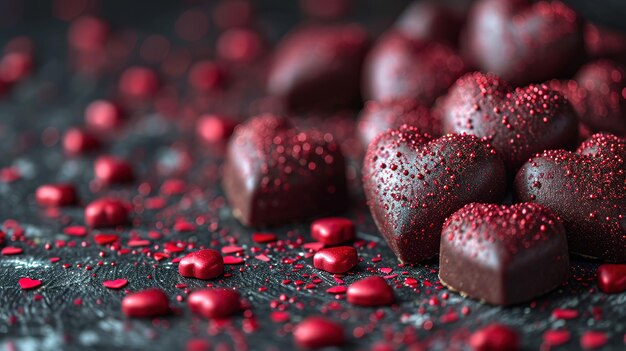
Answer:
top-left (267, 24), bottom-right (369, 111)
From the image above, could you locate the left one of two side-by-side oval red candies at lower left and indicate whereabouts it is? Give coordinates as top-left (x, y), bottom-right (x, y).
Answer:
top-left (122, 288), bottom-right (171, 318)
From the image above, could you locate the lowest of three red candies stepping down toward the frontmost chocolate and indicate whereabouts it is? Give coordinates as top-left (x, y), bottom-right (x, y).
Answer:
top-left (346, 276), bottom-right (395, 307)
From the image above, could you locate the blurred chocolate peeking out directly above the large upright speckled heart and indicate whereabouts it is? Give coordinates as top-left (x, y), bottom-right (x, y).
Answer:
top-left (358, 98), bottom-right (441, 147)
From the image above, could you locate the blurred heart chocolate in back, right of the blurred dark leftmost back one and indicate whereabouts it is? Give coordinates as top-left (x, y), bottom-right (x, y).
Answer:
top-left (363, 31), bottom-right (466, 106)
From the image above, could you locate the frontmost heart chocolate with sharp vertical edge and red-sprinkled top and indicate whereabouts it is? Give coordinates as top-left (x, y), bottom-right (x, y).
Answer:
top-left (439, 203), bottom-right (570, 305)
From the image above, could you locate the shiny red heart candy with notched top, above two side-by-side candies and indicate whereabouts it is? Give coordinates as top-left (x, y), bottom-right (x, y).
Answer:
top-left (178, 249), bottom-right (224, 280)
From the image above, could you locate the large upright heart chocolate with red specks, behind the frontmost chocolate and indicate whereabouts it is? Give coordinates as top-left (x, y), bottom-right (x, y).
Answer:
top-left (363, 126), bottom-right (506, 263)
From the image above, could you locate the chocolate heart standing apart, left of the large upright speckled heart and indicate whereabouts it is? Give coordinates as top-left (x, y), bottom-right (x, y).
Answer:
top-left (223, 115), bottom-right (347, 226)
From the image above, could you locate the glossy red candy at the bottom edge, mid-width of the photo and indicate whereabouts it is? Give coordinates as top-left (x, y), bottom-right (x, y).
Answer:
top-left (293, 316), bottom-right (346, 349)
